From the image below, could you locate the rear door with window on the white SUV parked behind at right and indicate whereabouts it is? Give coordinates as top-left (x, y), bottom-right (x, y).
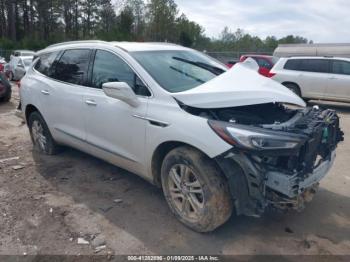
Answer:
top-left (297, 59), bottom-right (330, 99)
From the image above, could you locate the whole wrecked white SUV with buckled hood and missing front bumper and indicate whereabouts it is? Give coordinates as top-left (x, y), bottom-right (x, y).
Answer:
top-left (20, 41), bottom-right (343, 232)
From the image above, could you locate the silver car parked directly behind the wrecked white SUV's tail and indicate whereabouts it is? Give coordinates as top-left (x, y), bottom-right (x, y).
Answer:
top-left (7, 56), bottom-right (33, 81)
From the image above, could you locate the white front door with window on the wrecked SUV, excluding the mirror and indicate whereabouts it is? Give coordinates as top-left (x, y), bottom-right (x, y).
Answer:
top-left (83, 50), bottom-right (150, 173)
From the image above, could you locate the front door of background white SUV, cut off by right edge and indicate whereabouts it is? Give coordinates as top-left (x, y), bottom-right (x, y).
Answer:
top-left (325, 60), bottom-right (350, 101)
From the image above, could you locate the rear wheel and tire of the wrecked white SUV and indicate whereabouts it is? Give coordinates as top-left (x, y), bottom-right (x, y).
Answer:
top-left (28, 111), bottom-right (59, 155)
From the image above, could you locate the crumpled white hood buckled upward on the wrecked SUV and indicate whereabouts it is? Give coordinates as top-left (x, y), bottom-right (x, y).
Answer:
top-left (172, 64), bottom-right (306, 108)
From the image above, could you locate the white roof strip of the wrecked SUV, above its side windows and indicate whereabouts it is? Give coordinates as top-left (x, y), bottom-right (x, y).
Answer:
top-left (37, 40), bottom-right (188, 54)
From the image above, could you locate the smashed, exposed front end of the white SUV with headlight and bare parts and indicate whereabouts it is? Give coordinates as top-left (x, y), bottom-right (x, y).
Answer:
top-left (181, 103), bottom-right (344, 216)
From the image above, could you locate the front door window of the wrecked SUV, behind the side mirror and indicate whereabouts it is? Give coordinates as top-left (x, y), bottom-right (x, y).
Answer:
top-left (91, 50), bottom-right (151, 96)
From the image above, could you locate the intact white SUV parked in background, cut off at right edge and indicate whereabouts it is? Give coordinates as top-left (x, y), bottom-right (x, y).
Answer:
top-left (271, 57), bottom-right (350, 102)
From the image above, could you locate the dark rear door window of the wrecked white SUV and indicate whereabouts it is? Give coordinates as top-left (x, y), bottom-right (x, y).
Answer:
top-left (52, 49), bottom-right (91, 85)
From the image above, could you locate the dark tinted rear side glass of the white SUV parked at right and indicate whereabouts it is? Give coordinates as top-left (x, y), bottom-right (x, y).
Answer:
top-left (284, 59), bottom-right (330, 73)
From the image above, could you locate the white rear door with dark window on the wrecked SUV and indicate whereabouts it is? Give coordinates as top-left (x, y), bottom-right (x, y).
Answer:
top-left (41, 49), bottom-right (92, 144)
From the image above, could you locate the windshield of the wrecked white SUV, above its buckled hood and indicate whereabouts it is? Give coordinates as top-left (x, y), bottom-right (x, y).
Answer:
top-left (132, 50), bottom-right (226, 93)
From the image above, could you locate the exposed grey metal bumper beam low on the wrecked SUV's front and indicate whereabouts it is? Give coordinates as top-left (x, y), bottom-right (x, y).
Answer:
top-left (265, 151), bottom-right (336, 198)
